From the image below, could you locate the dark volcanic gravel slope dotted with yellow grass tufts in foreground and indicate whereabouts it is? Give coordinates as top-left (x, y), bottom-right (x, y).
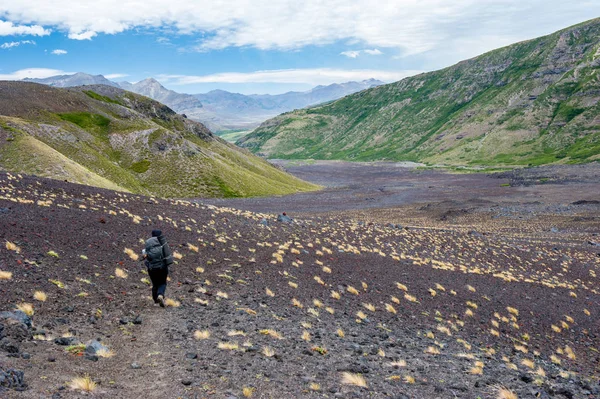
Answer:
top-left (0, 170), bottom-right (600, 398)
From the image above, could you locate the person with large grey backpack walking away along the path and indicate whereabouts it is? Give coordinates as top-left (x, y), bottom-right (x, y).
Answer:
top-left (142, 230), bottom-right (173, 308)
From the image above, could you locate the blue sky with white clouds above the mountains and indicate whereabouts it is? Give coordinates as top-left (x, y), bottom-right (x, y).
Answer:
top-left (0, 0), bottom-right (600, 94)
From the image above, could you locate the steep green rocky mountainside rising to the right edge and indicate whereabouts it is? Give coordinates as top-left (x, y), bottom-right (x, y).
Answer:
top-left (238, 19), bottom-right (600, 165)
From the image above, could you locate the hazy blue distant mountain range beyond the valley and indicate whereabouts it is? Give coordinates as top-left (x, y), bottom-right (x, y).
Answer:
top-left (25, 72), bottom-right (384, 132)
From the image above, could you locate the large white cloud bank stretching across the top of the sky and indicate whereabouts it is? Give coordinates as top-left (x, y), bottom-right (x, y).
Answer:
top-left (0, 0), bottom-right (600, 55)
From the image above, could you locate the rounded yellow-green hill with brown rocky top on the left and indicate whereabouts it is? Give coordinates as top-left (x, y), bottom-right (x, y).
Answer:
top-left (0, 82), bottom-right (315, 197)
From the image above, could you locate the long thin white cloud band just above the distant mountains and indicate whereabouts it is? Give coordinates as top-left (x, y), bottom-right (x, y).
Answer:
top-left (157, 68), bottom-right (421, 86)
